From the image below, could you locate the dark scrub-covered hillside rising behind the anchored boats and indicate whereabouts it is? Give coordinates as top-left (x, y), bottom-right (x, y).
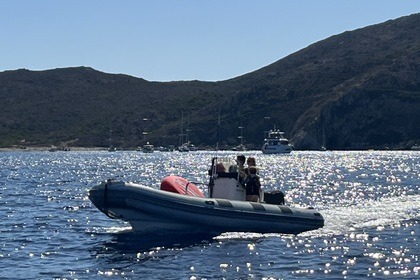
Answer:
top-left (0, 14), bottom-right (420, 149)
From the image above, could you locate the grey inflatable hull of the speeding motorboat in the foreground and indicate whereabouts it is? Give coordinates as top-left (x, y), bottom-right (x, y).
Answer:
top-left (89, 180), bottom-right (324, 234)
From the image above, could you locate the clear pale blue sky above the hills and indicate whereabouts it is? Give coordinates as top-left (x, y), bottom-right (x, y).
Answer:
top-left (0, 0), bottom-right (420, 81)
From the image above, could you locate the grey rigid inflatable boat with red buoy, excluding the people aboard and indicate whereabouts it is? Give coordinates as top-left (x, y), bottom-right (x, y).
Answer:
top-left (89, 158), bottom-right (324, 234)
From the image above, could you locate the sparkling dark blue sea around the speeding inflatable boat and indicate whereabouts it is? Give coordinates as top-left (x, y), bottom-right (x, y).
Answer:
top-left (0, 150), bottom-right (420, 280)
